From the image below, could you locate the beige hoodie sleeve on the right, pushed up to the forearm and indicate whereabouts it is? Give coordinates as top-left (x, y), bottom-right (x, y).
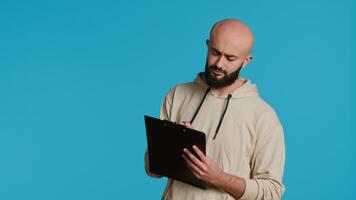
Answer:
top-left (241, 109), bottom-right (285, 200)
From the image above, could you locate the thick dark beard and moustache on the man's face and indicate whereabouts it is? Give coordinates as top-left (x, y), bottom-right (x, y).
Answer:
top-left (204, 62), bottom-right (242, 89)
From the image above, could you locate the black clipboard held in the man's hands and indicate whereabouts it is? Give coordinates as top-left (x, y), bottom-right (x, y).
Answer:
top-left (145, 115), bottom-right (207, 189)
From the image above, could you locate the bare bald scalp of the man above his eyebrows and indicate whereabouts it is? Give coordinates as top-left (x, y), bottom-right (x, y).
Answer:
top-left (210, 19), bottom-right (254, 56)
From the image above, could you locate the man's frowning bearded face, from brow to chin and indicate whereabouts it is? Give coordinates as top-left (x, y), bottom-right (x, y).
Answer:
top-left (204, 41), bottom-right (248, 89)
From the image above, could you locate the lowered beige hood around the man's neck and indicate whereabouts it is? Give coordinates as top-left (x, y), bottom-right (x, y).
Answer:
top-left (194, 72), bottom-right (258, 99)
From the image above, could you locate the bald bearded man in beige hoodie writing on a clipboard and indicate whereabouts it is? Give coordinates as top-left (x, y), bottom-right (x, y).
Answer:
top-left (145, 19), bottom-right (285, 200)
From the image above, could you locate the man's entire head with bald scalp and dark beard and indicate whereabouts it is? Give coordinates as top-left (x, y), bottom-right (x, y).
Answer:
top-left (204, 19), bottom-right (253, 90)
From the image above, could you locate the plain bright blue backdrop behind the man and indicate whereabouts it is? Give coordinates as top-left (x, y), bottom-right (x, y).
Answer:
top-left (0, 0), bottom-right (356, 200)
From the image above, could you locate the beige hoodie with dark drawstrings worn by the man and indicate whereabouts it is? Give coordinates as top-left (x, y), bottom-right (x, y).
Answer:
top-left (146, 75), bottom-right (285, 200)
